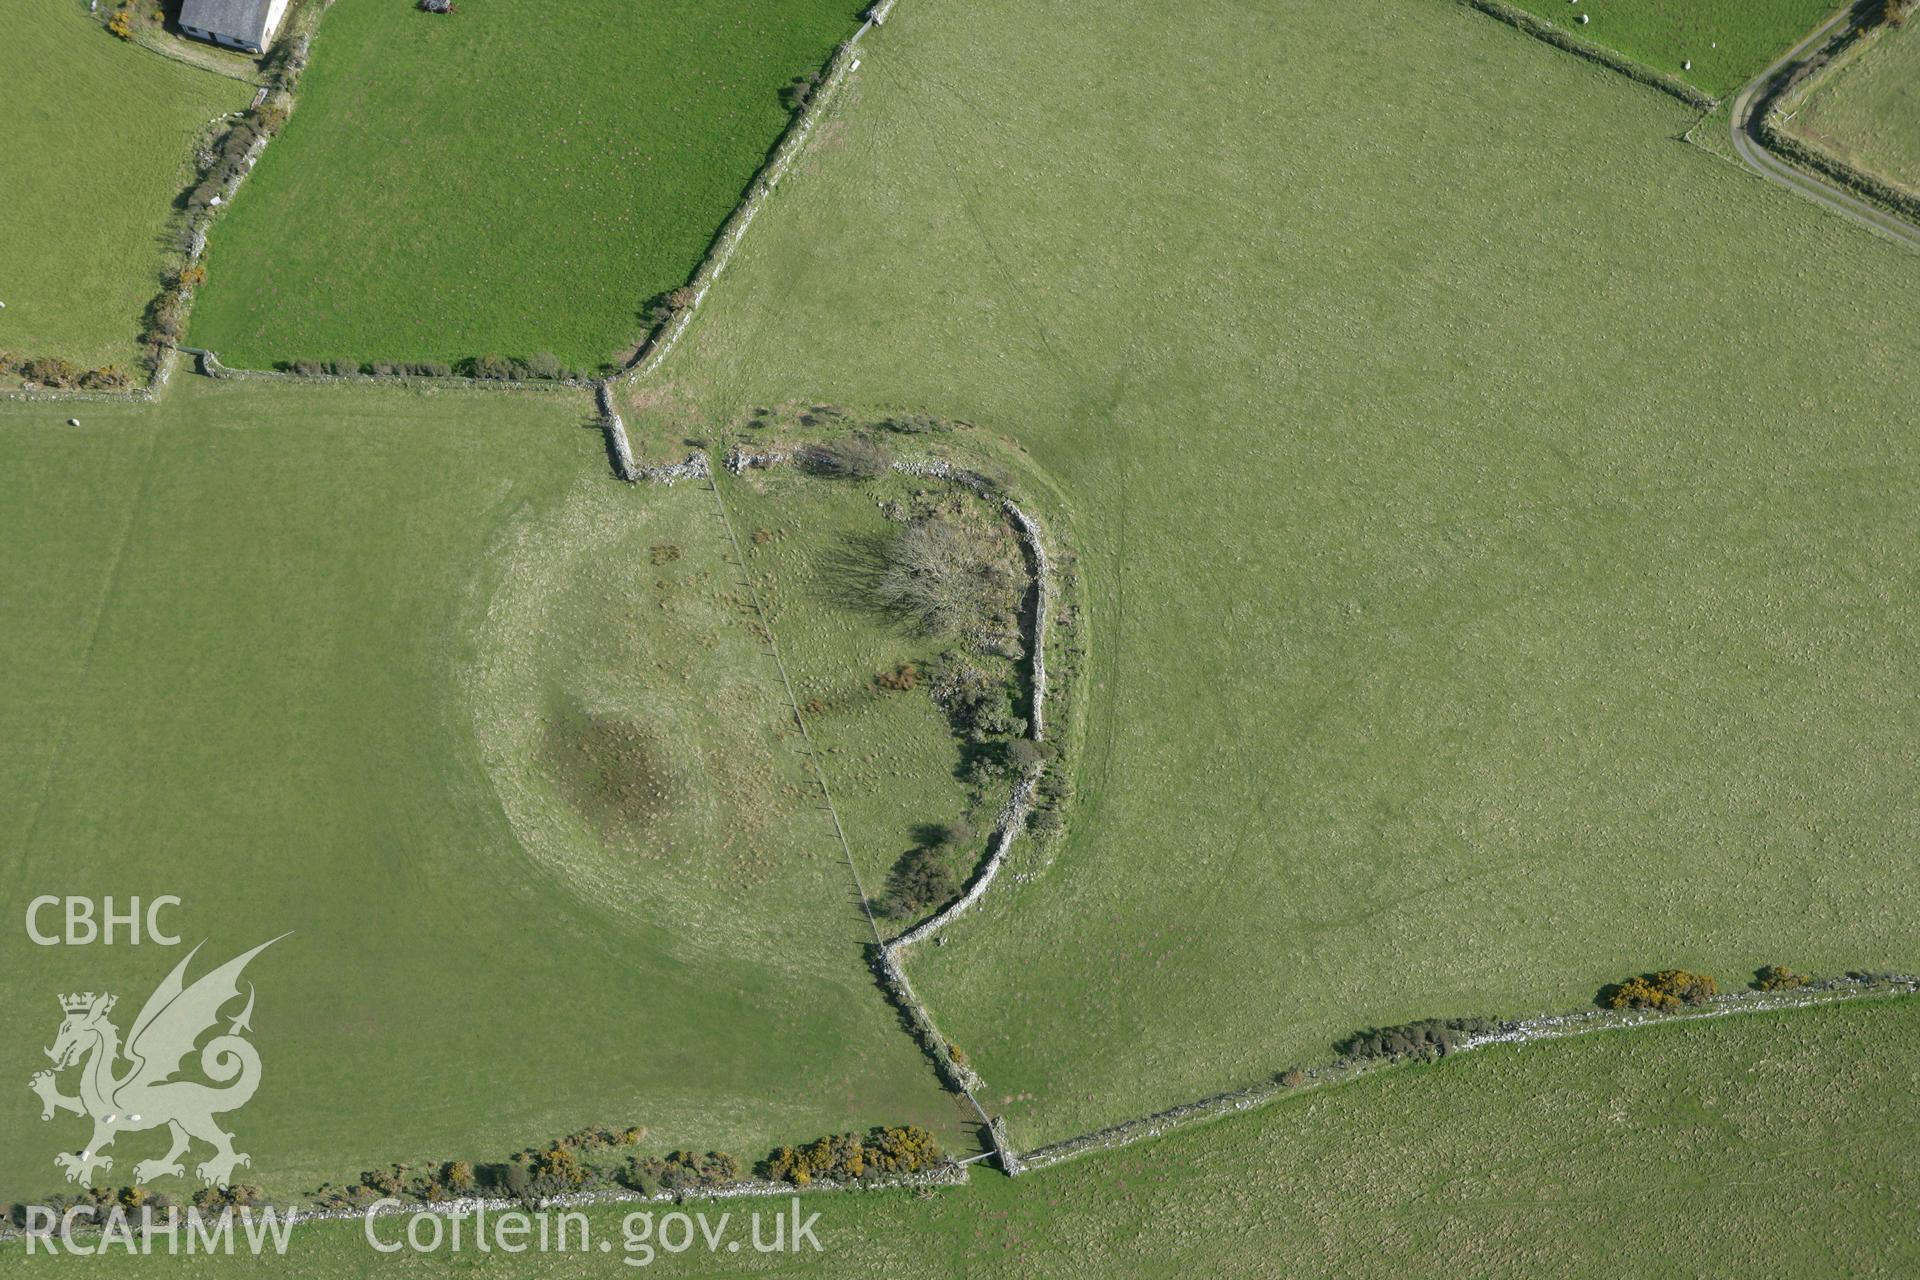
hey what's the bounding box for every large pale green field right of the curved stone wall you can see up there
[618,0,1920,1144]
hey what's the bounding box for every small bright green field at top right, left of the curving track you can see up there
[1511,0,1839,98]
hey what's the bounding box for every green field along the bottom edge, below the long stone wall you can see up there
[18,1000,1920,1278]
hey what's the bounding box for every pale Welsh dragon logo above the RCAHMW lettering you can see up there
[27,935,286,1186]
